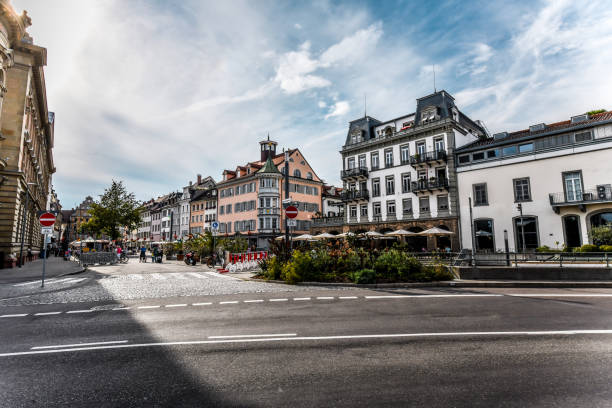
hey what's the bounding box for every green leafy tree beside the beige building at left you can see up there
[83,180,141,239]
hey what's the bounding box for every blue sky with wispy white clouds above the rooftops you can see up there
[12,0,612,208]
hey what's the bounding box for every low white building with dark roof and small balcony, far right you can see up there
[456,112,612,251]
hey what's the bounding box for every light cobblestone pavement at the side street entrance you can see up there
[0,259,334,306]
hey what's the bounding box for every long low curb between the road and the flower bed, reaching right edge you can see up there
[240,278,612,289]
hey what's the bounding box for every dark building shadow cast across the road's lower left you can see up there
[0,270,255,407]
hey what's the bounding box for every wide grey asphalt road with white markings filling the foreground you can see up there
[0,266,612,407]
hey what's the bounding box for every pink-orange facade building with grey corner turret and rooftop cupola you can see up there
[217,137,323,248]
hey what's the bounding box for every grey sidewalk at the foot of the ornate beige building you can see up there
[0,256,83,285]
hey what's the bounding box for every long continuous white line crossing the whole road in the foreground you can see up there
[0,330,612,357]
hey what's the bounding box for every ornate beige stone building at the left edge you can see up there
[0,0,55,267]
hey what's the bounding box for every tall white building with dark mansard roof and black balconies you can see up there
[326,91,486,250]
